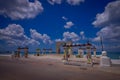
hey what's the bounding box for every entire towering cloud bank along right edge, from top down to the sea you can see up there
[92,0,120,51]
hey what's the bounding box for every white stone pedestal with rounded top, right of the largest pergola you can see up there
[100,51,111,67]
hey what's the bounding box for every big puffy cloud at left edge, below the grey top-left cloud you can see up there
[0,24,40,46]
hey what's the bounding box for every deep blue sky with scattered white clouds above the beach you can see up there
[0,0,120,51]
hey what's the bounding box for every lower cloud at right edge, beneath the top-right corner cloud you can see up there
[94,26,120,42]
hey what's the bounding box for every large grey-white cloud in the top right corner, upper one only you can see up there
[92,0,120,27]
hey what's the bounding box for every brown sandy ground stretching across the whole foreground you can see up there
[0,54,120,80]
